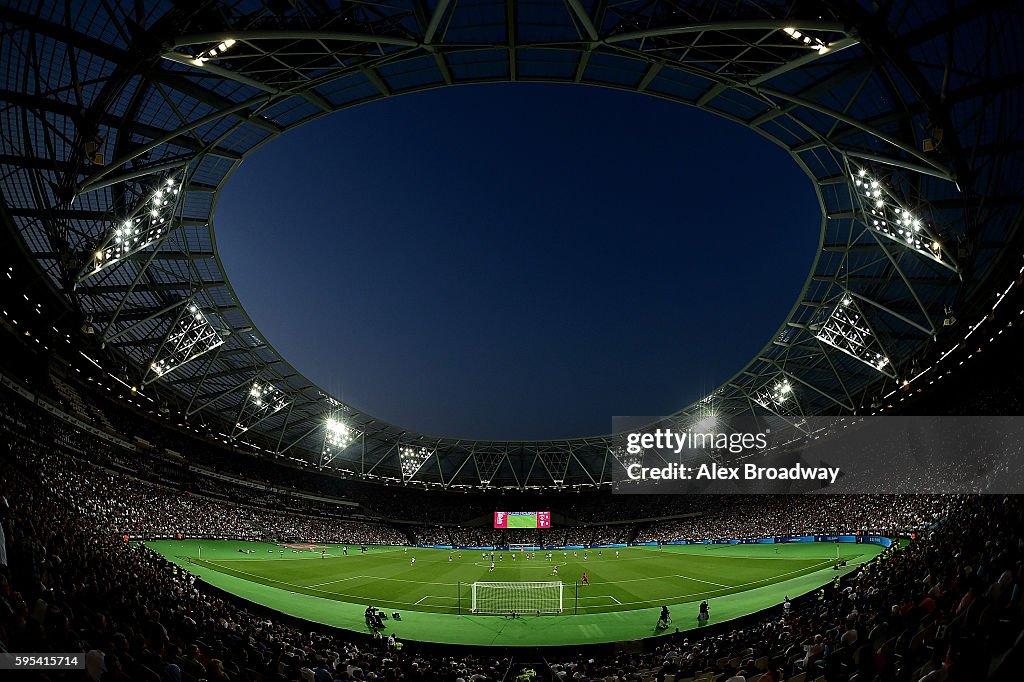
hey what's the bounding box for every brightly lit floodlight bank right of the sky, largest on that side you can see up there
[850,166,956,270]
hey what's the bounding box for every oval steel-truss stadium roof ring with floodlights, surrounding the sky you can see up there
[0,0,1024,486]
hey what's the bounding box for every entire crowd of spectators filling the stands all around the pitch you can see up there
[0,378,1024,682]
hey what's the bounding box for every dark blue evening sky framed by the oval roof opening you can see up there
[216,84,820,438]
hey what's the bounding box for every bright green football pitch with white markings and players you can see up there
[146,541,883,646]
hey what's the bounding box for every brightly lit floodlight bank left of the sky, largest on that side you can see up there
[78,172,184,282]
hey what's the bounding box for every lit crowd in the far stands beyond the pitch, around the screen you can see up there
[0,387,950,547]
